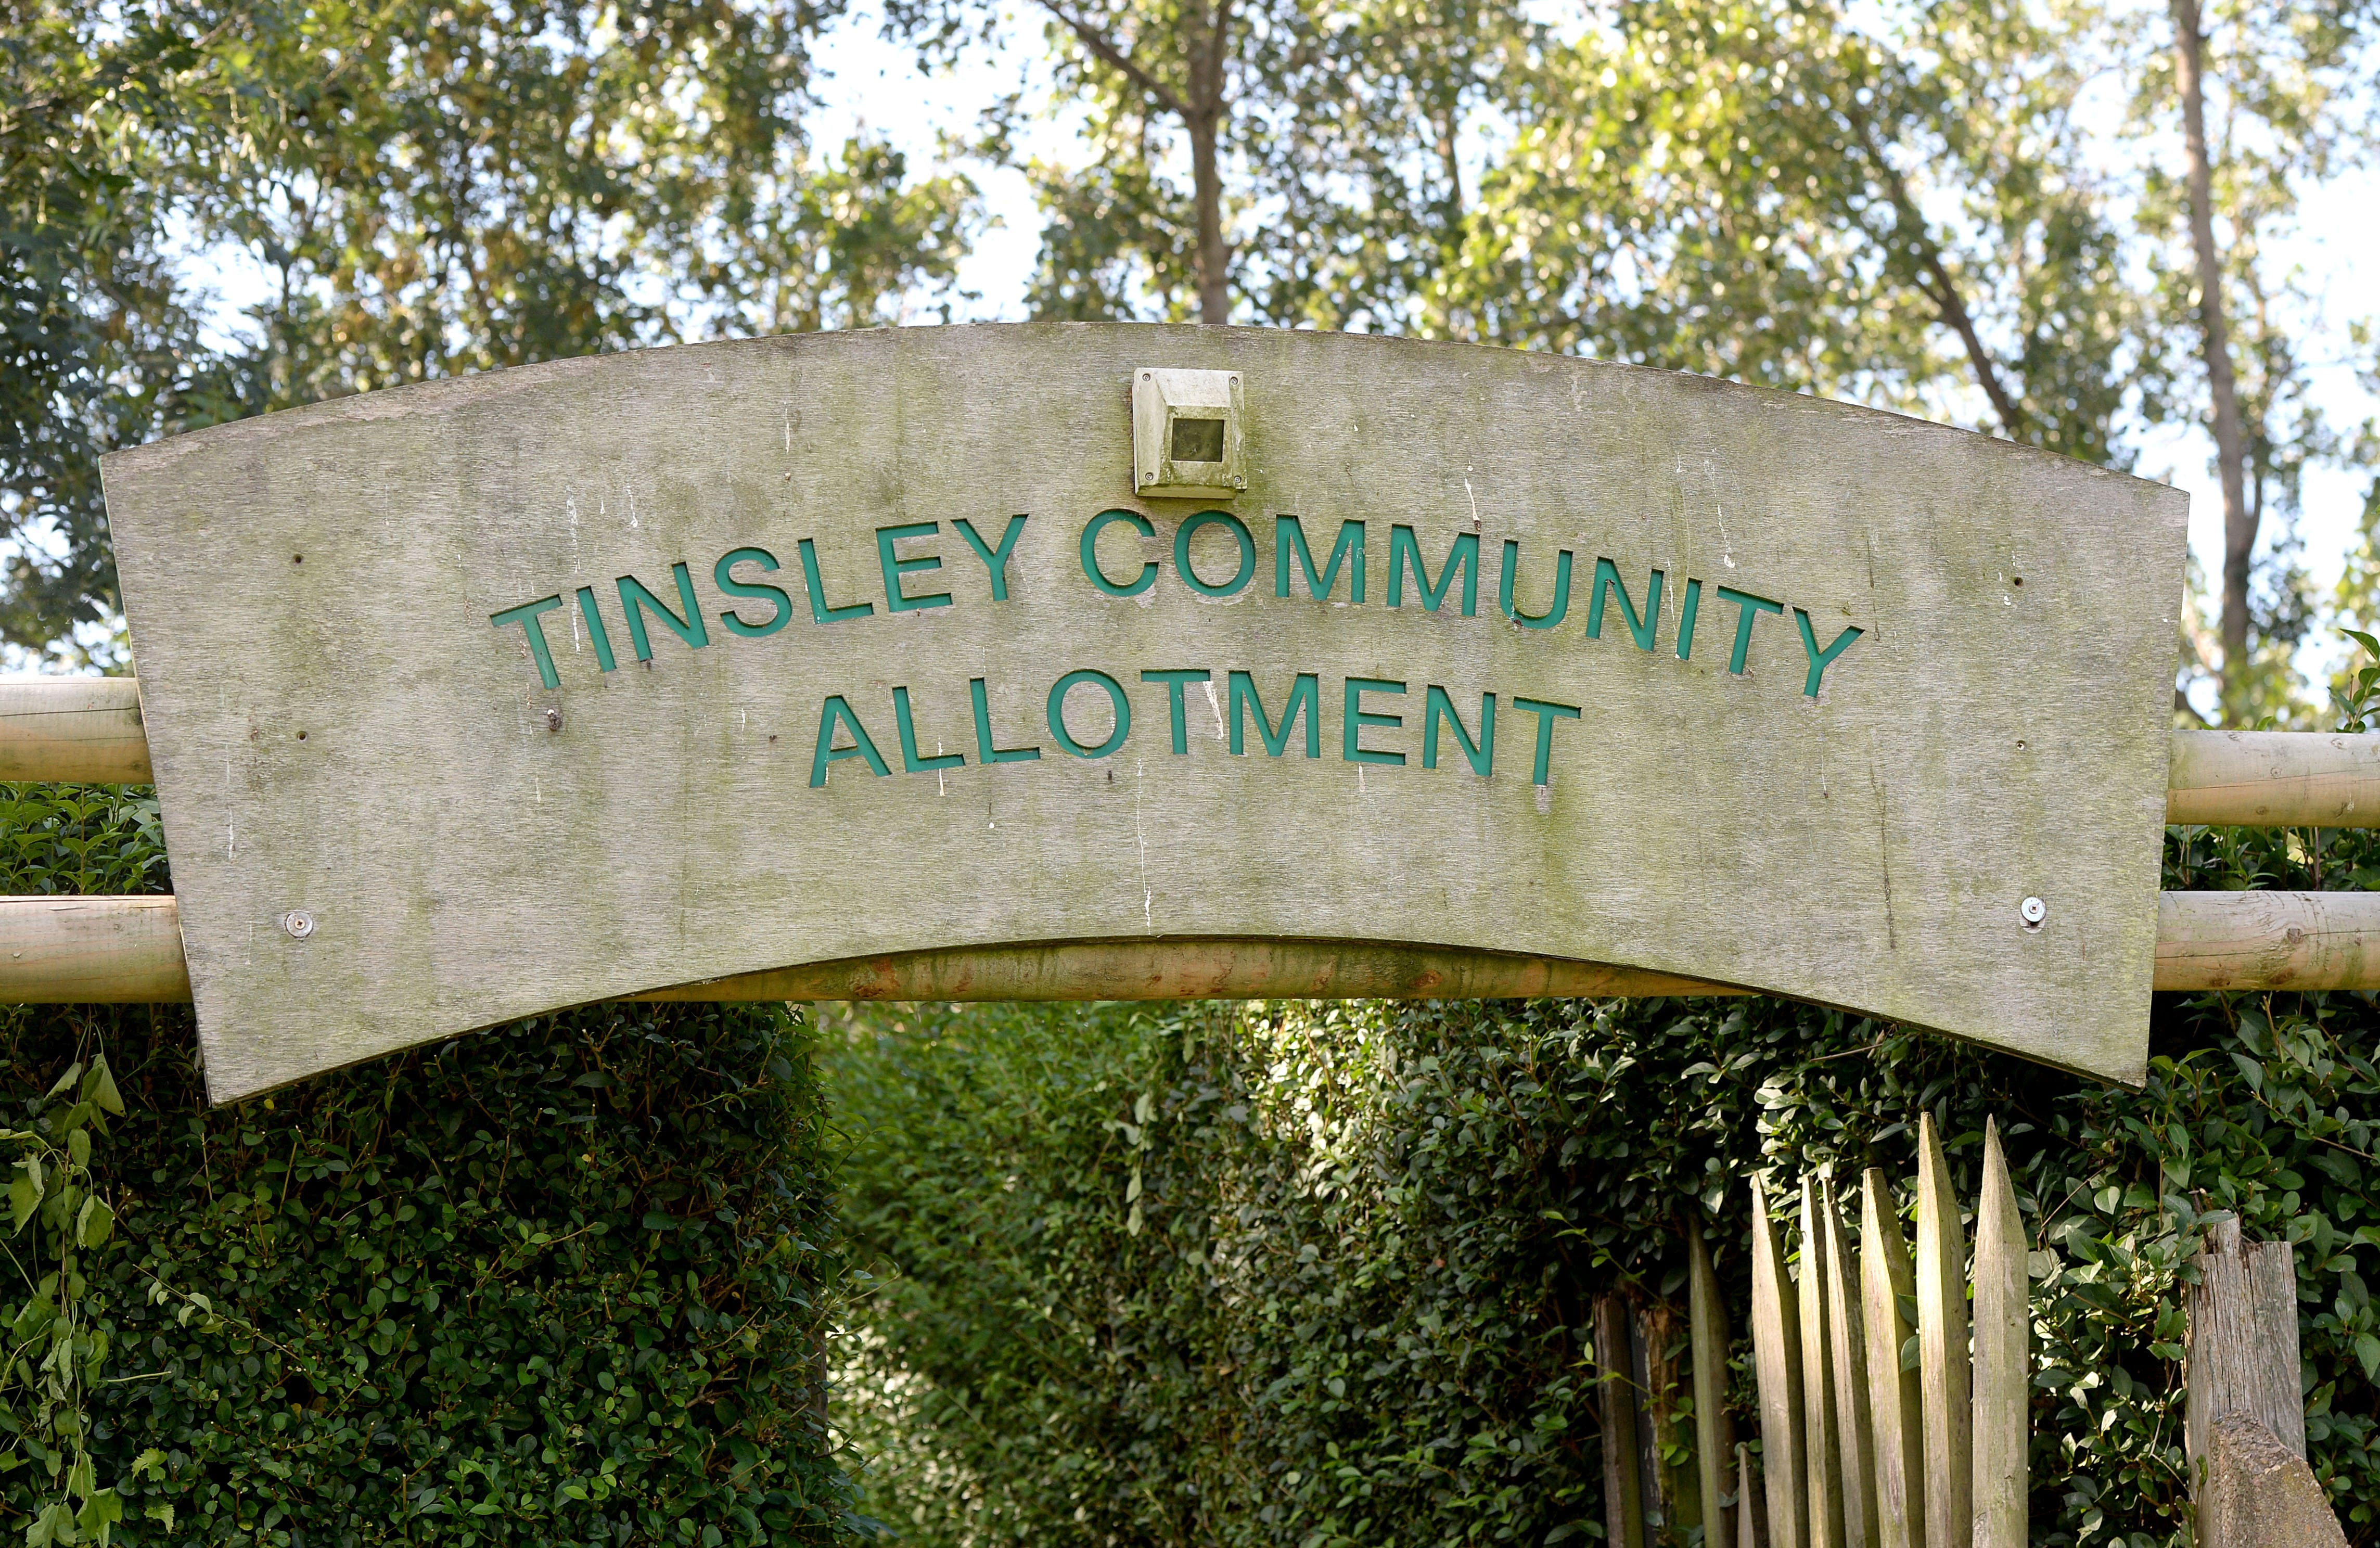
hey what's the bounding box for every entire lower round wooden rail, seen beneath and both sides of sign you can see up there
[0,893,2380,1005]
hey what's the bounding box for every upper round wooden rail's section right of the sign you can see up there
[2166,731,2380,829]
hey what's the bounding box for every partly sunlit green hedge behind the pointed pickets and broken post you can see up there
[826,829,2380,1548]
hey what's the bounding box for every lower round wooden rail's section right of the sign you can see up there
[2156,893,2380,988]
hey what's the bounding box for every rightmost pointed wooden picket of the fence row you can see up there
[1973,1119,2032,1548]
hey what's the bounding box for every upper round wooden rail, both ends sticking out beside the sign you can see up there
[0,676,2380,829]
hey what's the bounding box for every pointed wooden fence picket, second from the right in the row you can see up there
[1916,1112,1975,1548]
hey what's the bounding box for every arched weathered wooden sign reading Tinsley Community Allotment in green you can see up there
[105,324,2185,1101]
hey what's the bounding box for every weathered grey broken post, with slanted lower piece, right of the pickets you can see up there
[2182,1217,2347,1548]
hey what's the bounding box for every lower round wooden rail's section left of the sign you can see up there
[0,898,190,1005]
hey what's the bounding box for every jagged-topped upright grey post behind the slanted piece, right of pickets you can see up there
[2182,1217,2306,1477]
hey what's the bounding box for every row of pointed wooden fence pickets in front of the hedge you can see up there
[1597,1117,2030,1548]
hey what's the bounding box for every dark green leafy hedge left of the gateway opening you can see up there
[0,786,859,1548]
